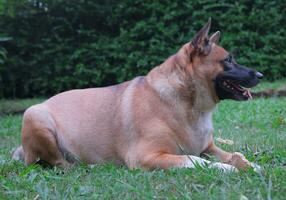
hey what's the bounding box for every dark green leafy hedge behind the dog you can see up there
[0,0,286,97]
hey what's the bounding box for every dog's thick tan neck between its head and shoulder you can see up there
[146,55,217,114]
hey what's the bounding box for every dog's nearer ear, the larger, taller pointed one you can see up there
[191,18,211,55]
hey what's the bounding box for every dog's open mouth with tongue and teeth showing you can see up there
[222,79,252,99]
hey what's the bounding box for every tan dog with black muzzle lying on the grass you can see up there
[12,19,263,171]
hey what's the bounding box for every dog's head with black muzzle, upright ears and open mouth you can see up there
[181,20,263,101]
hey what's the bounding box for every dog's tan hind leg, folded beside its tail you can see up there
[22,105,70,168]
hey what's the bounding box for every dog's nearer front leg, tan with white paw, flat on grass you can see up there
[140,154,236,172]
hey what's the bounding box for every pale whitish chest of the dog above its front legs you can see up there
[186,111,213,155]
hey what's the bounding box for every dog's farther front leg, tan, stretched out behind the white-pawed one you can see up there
[203,143,251,169]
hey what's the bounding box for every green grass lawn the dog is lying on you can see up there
[0,80,286,200]
